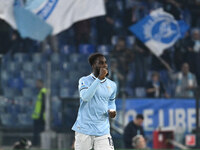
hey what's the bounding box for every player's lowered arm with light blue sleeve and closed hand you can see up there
[108,84,117,118]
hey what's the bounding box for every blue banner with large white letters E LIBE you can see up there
[116,98,196,145]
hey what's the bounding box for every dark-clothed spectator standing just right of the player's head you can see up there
[110,38,134,92]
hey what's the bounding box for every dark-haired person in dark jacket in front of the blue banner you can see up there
[123,114,144,148]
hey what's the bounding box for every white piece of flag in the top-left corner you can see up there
[0,0,17,29]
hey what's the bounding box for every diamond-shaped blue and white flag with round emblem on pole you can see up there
[130,9,189,56]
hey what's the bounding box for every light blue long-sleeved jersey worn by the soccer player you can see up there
[72,74,117,136]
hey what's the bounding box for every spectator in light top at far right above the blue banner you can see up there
[170,63,197,98]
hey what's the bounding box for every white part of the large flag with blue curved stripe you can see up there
[25,0,105,34]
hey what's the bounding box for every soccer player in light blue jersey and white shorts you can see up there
[72,53,117,150]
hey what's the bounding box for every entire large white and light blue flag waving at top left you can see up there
[0,0,105,41]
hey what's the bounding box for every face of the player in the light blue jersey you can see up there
[94,57,108,75]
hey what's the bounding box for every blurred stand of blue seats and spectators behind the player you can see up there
[0,0,200,144]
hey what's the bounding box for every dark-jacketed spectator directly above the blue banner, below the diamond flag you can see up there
[146,72,169,98]
